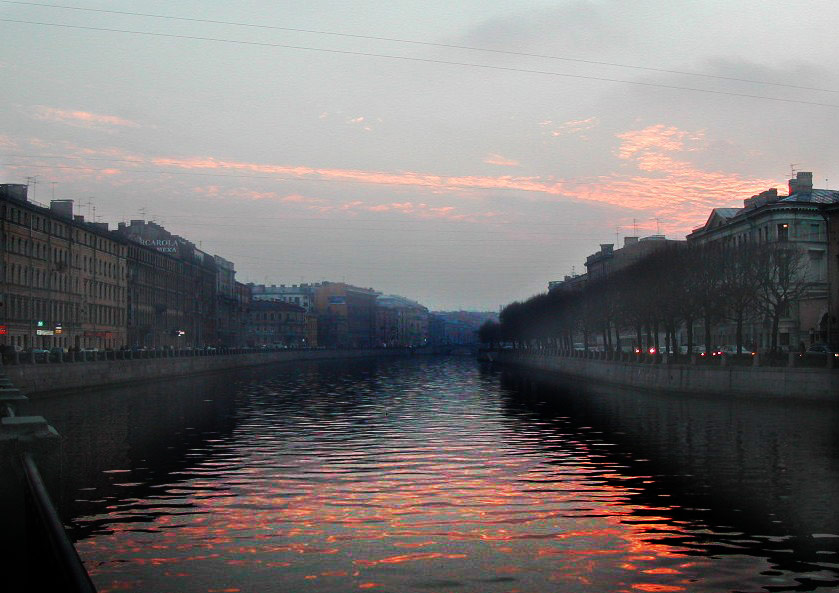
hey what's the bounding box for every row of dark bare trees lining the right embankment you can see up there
[480,243,811,353]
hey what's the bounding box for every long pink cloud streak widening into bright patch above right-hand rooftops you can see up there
[146,147,776,233]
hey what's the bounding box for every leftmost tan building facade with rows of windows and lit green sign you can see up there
[0,184,127,349]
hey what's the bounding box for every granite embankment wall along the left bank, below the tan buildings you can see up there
[3,349,408,395]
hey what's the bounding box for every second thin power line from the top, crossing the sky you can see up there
[0,18,839,108]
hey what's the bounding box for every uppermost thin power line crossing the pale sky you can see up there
[0,0,839,93]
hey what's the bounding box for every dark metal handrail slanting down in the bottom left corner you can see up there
[21,452,96,593]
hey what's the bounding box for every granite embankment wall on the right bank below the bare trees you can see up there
[494,351,839,401]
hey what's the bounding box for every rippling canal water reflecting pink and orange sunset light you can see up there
[31,357,839,593]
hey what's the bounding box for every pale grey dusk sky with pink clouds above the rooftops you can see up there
[0,0,839,310]
